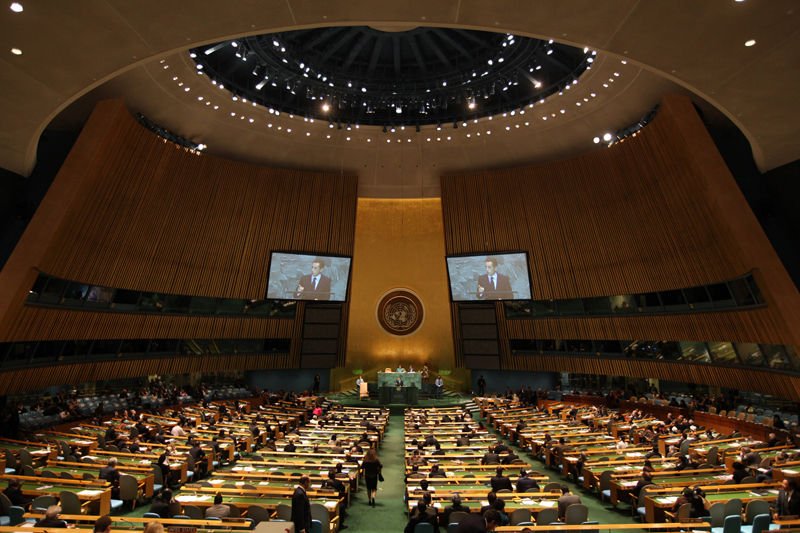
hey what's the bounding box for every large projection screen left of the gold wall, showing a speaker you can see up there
[265,252,351,302]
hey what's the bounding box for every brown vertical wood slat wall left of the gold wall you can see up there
[0,101,358,378]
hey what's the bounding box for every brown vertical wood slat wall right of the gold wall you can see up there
[441,94,794,391]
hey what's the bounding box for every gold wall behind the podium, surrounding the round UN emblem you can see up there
[332,198,467,388]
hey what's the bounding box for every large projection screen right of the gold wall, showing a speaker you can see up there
[447,252,531,302]
